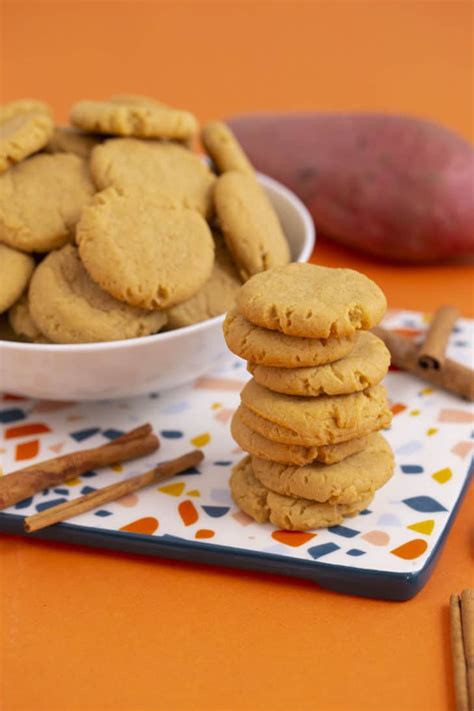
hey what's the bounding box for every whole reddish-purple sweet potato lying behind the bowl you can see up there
[227,113,474,262]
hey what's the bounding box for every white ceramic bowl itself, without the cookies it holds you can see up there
[0,175,315,400]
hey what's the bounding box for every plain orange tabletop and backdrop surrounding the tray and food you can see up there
[0,0,474,711]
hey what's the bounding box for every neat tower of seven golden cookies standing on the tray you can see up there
[224,264,393,530]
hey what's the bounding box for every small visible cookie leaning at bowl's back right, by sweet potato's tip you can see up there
[202,121,255,175]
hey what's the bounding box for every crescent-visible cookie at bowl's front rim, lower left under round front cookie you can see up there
[29,245,166,343]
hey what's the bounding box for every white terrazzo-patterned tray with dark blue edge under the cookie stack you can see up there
[0,312,474,600]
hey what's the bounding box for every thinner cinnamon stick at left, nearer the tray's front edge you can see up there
[24,449,204,533]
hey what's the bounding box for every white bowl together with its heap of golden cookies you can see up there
[0,95,315,400]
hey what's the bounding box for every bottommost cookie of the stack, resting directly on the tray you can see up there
[230,457,373,531]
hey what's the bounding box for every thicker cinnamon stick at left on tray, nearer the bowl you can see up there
[0,424,160,510]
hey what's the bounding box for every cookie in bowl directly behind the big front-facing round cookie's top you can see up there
[91,138,216,216]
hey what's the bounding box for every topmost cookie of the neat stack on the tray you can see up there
[235,262,387,338]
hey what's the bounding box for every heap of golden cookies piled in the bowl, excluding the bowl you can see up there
[0,95,290,343]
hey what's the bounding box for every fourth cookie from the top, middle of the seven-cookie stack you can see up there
[240,379,391,447]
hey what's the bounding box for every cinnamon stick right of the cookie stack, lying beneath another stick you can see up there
[373,326,474,402]
